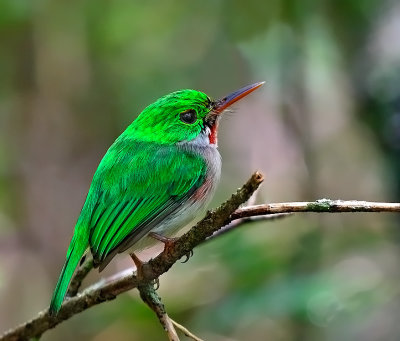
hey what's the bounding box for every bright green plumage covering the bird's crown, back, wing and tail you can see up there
[50,90,211,314]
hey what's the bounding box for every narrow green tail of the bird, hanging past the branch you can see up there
[49,232,87,316]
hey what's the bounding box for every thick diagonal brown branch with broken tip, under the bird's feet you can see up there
[0,172,263,341]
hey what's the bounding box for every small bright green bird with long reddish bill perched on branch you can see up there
[49,82,264,315]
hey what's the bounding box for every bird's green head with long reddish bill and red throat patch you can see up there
[125,82,264,145]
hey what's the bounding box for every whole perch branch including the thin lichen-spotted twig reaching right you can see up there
[0,177,400,341]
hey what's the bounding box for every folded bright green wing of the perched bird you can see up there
[82,140,206,270]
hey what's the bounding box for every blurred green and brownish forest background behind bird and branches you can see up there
[0,0,400,341]
